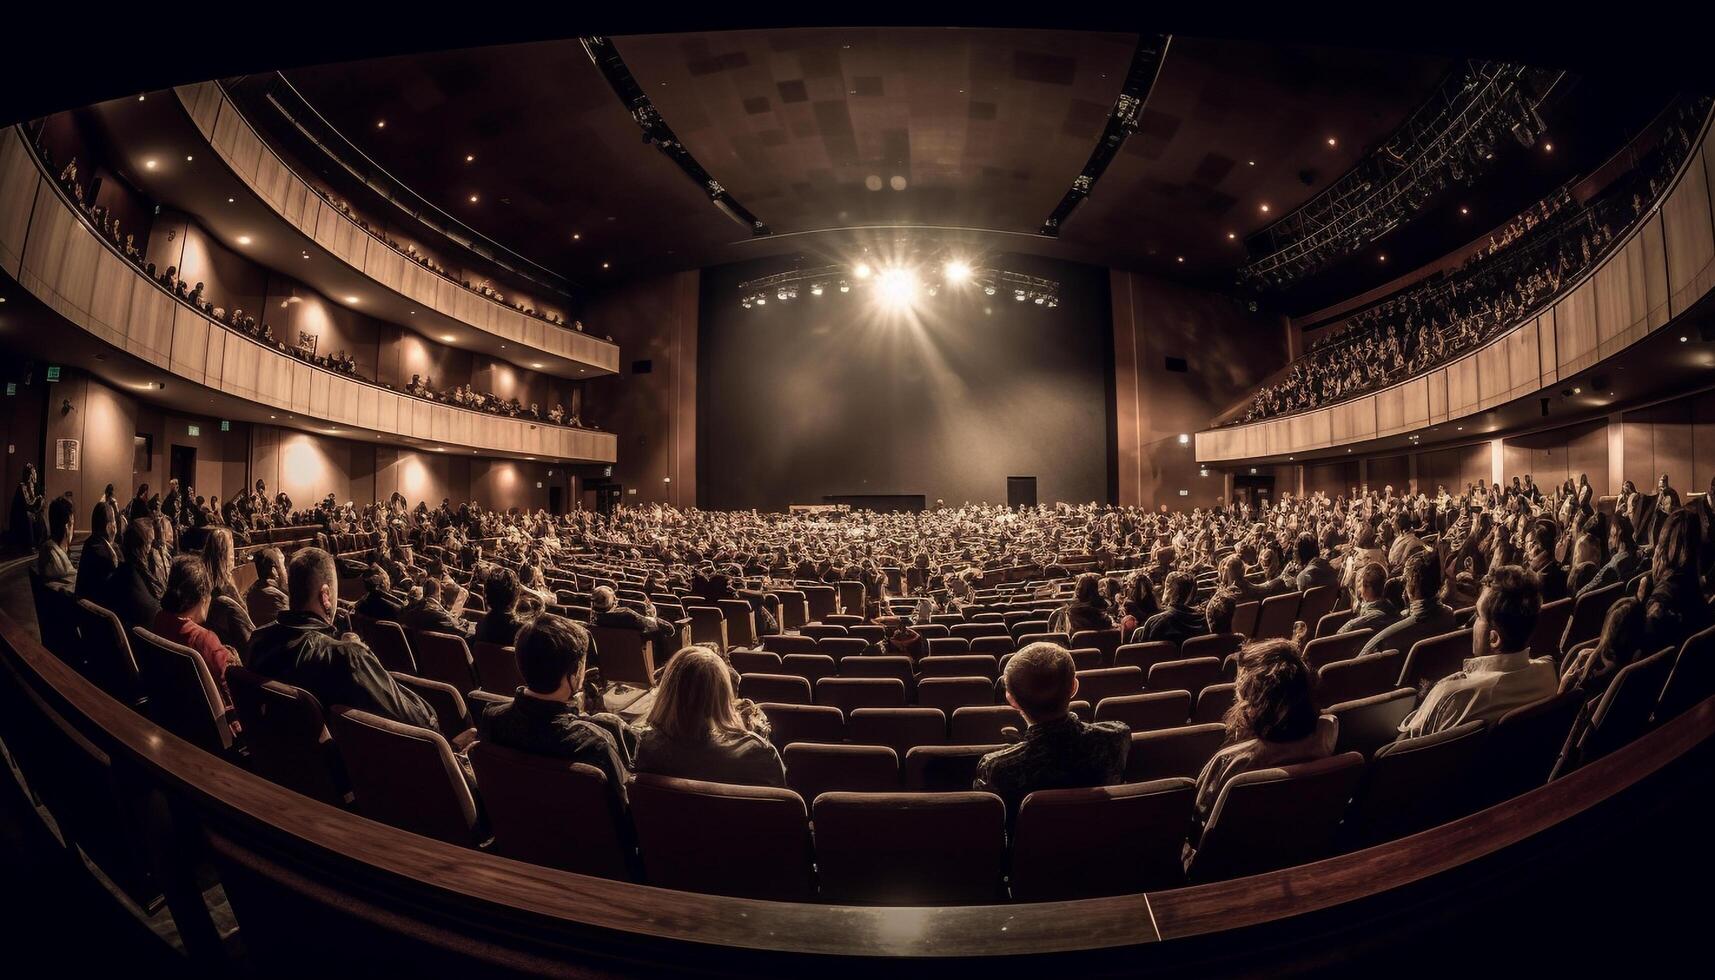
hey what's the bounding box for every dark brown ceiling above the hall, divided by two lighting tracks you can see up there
[277,27,1451,285]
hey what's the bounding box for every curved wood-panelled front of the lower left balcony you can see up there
[0,127,617,462]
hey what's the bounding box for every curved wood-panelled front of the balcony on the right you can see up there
[1197,108,1715,463]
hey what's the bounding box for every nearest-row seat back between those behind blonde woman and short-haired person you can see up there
[811,793,1007,904]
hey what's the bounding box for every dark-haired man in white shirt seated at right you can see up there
[1399,565,1559,736]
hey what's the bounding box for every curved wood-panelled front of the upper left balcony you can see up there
[173,82,619,378]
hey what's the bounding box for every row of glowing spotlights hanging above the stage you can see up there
[739,249,1060,309]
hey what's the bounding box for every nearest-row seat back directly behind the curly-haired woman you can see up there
[1185,752,1363,884]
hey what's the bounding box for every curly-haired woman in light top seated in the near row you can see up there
[1197,640,1339,824]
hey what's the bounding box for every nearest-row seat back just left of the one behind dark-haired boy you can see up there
[331,705,482,848]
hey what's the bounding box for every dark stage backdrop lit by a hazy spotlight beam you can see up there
[696,256,1115,510]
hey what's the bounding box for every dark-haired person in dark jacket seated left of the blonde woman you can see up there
[477,614,636,800]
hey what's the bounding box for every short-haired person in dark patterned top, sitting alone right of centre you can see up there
[971,644,1132,820]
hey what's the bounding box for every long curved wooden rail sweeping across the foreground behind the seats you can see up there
[0,590,1715,963]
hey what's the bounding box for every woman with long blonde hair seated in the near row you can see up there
[636,647,785,786]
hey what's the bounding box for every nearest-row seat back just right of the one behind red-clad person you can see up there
[226,664,350,807]
